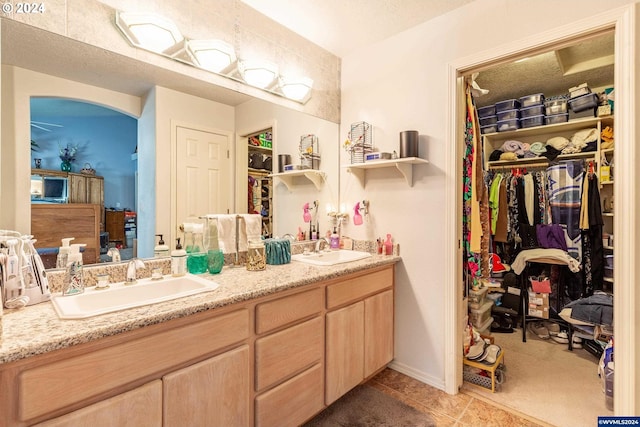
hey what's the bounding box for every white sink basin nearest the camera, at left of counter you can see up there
[51,274,220,319]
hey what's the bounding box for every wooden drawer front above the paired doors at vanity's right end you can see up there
[327,267,393,309]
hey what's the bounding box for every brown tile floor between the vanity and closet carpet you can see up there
[368,368,548,427]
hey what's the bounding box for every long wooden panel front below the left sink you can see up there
[17,309,250,421]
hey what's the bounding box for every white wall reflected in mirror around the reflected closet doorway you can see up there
[236,99,339,236]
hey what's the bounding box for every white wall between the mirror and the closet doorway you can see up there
[340,0,633,388]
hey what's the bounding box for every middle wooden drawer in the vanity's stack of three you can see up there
[255,317,324,391]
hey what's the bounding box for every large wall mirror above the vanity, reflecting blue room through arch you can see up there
[0,18,339,268]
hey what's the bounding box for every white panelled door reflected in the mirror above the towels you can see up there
[175,126,231,225]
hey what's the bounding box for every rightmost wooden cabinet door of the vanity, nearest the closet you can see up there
[364,291,393,378]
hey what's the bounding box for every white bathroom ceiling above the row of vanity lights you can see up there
[241,0,473,57]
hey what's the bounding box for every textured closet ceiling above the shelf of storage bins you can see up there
[476,32,614,107]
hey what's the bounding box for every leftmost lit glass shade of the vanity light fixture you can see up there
[116,12,184,53]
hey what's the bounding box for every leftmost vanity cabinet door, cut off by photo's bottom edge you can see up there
[35,380,162,427]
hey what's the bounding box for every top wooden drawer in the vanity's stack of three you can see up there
[256,288,323,334]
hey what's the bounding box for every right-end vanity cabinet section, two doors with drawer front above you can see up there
[325,269,393,405]
